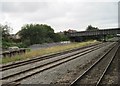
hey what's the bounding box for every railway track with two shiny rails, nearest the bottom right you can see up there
[69,43,120,86]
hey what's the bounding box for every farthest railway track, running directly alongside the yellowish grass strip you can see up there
[0,43,102,71]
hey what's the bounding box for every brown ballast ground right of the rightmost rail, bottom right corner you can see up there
[100,47,120,86]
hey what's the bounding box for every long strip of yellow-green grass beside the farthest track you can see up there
[0,40,98,64]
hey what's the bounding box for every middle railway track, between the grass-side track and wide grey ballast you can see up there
[1,44,114,82]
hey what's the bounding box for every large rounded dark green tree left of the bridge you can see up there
[19,24,54,45]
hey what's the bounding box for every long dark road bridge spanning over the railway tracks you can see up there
[66,28,120,41]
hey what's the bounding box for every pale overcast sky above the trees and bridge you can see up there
[0,0,119,33]
